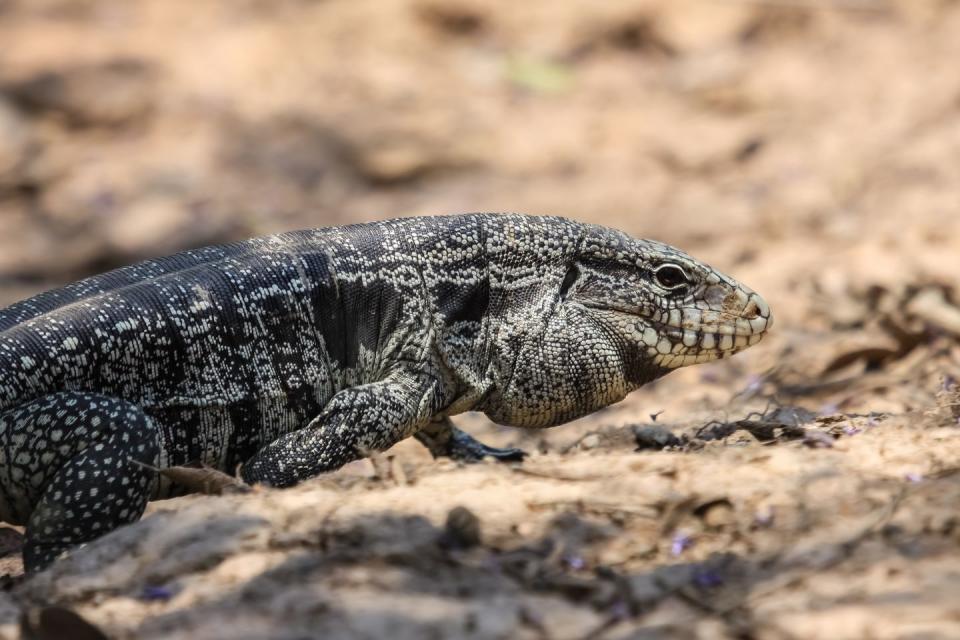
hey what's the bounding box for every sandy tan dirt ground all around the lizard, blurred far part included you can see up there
[0,0,960,640]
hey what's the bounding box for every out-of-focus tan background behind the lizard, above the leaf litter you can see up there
[0,0,960,308]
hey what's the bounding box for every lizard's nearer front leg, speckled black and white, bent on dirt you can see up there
[240,371,441,487]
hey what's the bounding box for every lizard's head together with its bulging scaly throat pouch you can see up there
[487,218,773,426]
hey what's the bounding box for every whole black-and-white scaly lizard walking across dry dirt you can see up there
[0,214,771,570]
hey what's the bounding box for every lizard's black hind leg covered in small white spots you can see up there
[0,392,160,572]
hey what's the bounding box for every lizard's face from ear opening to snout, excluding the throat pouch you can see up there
[558,232,773,370]
